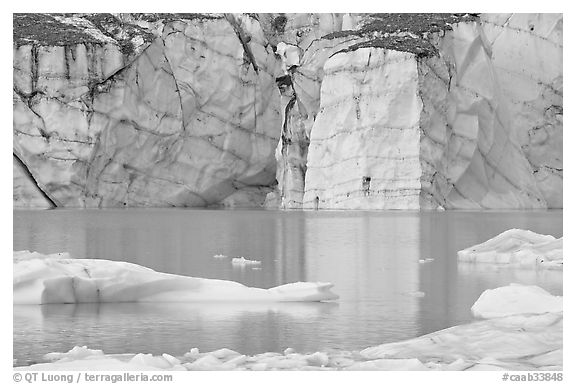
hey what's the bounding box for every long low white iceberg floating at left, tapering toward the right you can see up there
[14,251,338,304]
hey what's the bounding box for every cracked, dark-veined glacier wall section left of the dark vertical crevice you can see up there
[14,15,280,207]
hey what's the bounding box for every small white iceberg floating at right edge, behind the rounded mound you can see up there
[458,229,563,268]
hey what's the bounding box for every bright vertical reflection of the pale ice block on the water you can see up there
[306,212,420,348]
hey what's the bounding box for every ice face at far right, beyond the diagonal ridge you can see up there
[482,13,563,208]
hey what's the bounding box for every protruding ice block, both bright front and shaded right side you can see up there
[304,16,558,209]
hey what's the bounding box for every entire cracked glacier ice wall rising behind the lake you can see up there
[14,14,563,209]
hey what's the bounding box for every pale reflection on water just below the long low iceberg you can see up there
[14,303,338,363]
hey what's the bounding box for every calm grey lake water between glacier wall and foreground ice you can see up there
[13,209,563,365]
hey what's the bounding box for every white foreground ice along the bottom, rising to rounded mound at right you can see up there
[16,285,563,371]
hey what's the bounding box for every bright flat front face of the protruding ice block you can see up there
[304,48,421,209]
